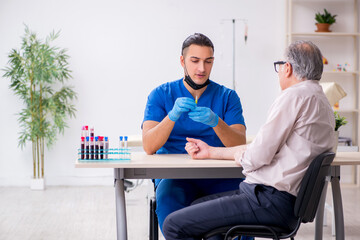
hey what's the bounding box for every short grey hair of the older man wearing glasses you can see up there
[285,41,324,80]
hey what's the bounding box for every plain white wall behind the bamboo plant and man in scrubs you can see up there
[0,0,285,186]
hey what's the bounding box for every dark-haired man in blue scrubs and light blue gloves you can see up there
[142,33,246,235]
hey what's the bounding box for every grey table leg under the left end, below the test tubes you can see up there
[114,168,127,240]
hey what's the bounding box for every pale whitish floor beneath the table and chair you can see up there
[0,184,360,240]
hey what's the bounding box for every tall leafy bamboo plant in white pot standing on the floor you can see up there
[4,26,76,189]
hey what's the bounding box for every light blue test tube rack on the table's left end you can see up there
[78,148,131,161]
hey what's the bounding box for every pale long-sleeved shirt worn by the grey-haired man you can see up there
[238,80,335,196]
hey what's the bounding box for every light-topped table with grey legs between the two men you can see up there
[75,152,360,240]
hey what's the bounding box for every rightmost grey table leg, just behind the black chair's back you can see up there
[331,166,345,240]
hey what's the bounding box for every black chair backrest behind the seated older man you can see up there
[294,152,335,223]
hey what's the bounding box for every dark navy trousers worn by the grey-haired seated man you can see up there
[163,182,297,240]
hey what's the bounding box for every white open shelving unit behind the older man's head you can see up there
[286,0,360,145]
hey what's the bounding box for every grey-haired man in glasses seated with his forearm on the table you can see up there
[163,41,335,240]
